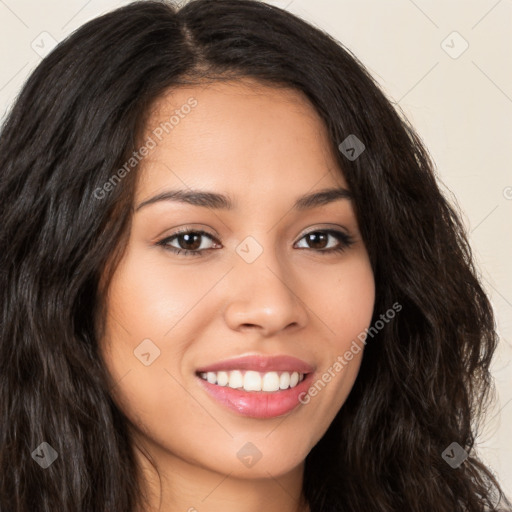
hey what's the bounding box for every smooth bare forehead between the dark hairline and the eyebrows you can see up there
[138,80,346,197]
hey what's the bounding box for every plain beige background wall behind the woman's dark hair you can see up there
[0,0,512,497]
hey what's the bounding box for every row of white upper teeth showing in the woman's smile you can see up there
[199,370,304,392]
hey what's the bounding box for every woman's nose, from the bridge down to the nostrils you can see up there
[224,244,308,337]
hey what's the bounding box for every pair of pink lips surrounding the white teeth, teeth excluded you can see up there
[196,356,314,418]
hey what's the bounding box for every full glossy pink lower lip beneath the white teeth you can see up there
[197,373,313,418]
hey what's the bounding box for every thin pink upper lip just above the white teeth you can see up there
[196,355,314,373]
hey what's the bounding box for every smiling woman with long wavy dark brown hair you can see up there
[0,0,510,512]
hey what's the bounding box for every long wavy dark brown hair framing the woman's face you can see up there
[0,0,510,512]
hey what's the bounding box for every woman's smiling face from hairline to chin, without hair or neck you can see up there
[101,81,375,478]
